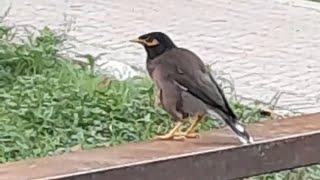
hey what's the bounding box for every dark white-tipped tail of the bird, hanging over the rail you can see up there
[207,110,253,144]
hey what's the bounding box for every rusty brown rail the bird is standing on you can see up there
[0,113,320,180]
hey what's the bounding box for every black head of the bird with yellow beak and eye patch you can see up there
[130,32,176,60]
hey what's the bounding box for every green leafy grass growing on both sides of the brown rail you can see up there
[0,26,320,179]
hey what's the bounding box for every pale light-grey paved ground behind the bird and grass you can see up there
[0,0,320,113]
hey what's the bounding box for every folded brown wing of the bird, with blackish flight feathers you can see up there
[161,49,235,117]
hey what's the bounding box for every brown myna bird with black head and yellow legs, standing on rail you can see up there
[131,32,253,144]
